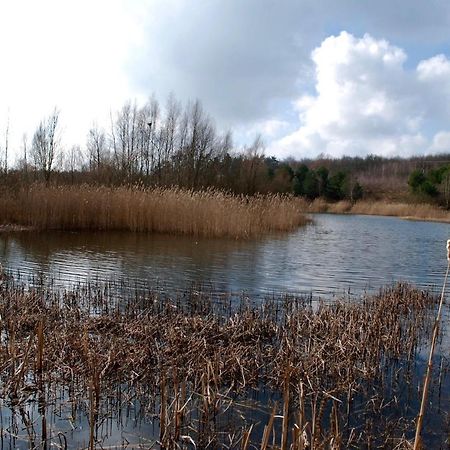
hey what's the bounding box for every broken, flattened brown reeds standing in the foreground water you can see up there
[0,278,444,449]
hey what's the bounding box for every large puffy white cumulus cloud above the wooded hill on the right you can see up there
[269,32,450,157]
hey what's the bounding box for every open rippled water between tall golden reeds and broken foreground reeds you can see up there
[0,215,449,296]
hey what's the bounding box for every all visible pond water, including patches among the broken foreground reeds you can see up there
[0,214,450,449]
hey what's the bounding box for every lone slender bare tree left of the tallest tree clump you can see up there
[31,109,60,183]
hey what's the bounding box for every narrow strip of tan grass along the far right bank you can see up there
[304,199,450,222]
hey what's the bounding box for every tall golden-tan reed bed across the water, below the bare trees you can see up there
[0,185,306,239]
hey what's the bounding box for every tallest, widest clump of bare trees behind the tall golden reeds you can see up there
[107,95,231,189]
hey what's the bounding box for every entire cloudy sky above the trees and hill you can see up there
[0,0,450,162]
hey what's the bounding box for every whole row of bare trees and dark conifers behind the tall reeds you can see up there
[0,95,370,200]
